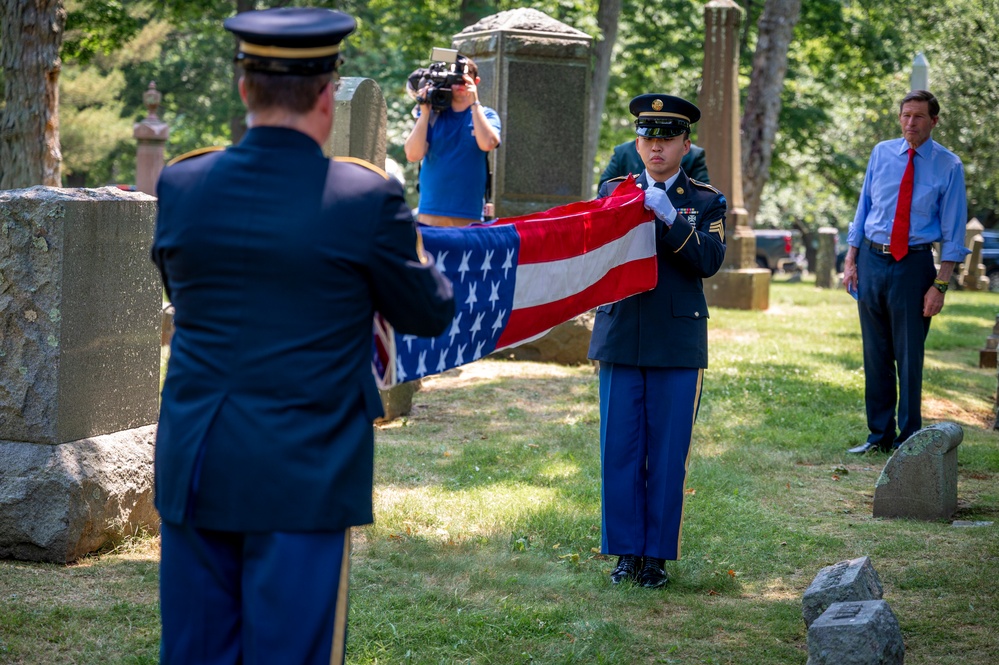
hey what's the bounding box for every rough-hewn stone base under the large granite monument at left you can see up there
[0,425,160,563]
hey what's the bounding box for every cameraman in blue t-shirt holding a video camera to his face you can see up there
[405,56,500,226]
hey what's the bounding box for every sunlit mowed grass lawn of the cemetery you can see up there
[0,281,999,665]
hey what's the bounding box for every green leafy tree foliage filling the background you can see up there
[52,0,999,232]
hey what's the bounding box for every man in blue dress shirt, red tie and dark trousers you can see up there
[843,90,969,453]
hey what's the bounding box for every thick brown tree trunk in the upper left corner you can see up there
[0,0,66,189]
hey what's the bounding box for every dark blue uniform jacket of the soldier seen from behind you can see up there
[152,127,454,531]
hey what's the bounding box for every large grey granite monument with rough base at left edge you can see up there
[0,187,162,562]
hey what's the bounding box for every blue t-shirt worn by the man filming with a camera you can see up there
[420,106,500,220]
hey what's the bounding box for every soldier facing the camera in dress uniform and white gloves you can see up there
[589,94,727,588]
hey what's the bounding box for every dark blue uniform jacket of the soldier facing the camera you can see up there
[589,169,727,368]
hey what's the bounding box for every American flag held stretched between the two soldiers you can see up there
[372,178,657,390]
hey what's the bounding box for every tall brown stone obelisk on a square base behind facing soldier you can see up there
[697,0,770,310]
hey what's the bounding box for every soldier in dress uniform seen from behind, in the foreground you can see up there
[152,8,454,665]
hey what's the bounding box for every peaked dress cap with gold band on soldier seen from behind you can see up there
[222,7,357,76]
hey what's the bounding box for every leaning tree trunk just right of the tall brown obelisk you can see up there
[742,0,801,226]
